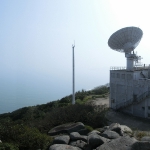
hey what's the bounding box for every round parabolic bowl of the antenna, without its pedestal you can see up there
[108,27,143,53]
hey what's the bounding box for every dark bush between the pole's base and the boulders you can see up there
[38,104,107,132]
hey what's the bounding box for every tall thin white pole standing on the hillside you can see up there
[72,45,75,104]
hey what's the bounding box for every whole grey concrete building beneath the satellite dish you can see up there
[109,65,150,118]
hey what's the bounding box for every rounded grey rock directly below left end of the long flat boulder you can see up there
[53,135,70,144]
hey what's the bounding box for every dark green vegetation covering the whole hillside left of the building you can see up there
[0,86,109,150]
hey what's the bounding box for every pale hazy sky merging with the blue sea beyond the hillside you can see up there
[0,0,150,113]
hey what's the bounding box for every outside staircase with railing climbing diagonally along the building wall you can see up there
[116,91,150,110]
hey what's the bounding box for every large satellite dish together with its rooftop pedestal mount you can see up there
[108,27,143,71]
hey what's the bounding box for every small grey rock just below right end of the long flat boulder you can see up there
[70,132,87,142]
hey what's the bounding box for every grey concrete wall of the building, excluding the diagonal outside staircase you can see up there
[110,69,150,118]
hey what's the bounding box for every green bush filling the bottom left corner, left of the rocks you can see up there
[0,122,53,150]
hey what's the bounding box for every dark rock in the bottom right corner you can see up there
[131,141,150,150]
